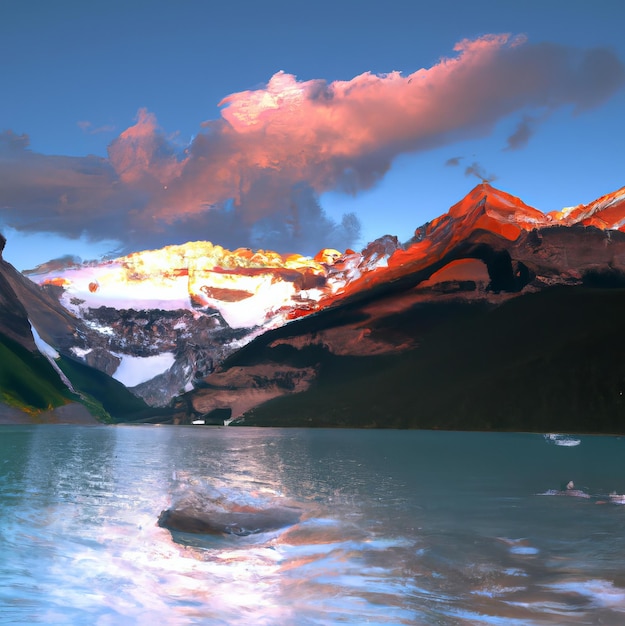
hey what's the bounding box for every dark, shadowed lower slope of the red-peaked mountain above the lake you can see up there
[244,287,625,433]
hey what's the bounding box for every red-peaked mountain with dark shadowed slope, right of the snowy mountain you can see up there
[172,180,625,432]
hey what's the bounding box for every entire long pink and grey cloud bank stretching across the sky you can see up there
[0,35,625,253]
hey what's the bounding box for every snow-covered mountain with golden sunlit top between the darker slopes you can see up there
[29,237,399,405]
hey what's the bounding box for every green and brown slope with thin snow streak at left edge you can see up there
[0,235,166,423]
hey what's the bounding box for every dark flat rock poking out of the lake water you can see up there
[158,506,302,537]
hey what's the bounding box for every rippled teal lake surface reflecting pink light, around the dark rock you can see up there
[0,426,625,626]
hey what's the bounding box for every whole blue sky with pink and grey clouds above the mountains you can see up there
[0,0,625,270]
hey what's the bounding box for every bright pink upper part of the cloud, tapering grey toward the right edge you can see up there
[143,35,625,225]
